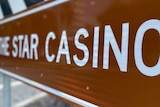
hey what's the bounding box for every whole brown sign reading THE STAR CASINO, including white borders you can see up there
[0,0,160,107]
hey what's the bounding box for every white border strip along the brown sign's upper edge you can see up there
[0,0,69,25]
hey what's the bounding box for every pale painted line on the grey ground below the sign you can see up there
[13,92,47,107]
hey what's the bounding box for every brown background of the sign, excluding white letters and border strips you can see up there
[0,0,160,107]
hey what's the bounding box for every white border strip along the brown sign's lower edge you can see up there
[0,68,99,107]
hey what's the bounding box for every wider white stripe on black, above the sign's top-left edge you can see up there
[8,0,27,14]
